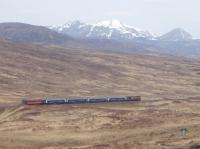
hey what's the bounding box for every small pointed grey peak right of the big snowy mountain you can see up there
[159,28,192,41]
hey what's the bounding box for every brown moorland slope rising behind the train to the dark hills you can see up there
[0,41,200,103]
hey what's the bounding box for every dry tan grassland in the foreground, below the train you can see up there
[0,100,200,149]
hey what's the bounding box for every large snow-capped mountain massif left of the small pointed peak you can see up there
[50,20,155,40]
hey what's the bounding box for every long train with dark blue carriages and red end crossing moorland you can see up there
[22,96,141,105]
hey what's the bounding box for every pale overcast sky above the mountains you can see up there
[0,0,200,38]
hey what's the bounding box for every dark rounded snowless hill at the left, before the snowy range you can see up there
[0,23,73,44]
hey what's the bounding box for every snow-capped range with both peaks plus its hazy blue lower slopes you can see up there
[50,20,200,57]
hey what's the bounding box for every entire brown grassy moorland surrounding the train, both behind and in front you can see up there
[0,41,200,149]
